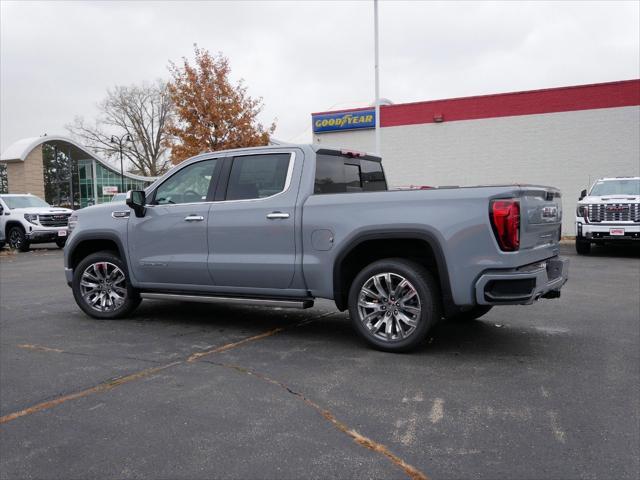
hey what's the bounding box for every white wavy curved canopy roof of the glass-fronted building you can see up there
[0,135,157,182]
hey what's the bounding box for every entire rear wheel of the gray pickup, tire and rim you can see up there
[349,258,440,352]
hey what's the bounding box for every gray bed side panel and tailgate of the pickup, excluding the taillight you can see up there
[303,185,562,305]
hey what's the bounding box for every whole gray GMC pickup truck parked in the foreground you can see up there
[65,145,568,351]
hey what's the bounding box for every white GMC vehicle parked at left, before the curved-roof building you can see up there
[0,194,73,252]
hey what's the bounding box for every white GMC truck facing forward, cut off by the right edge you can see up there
[576,177,640,251]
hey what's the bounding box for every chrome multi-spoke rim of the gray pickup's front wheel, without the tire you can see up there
[80,262,127,312]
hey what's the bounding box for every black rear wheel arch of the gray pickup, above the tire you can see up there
[333,229,453,310]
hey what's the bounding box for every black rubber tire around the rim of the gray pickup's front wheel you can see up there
[72,251,141,320]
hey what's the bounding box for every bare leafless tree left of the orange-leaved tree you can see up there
[66,80,173,176]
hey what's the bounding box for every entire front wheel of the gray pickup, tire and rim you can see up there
[72,251,140,319]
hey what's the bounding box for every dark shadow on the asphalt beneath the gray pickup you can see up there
[129,301,556,358]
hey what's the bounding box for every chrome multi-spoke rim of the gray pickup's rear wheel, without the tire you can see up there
[358,273,422,341]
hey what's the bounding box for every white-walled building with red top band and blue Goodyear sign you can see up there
[312,80,640,235]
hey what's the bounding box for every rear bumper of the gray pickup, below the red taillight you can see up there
[475,256,569,305]
